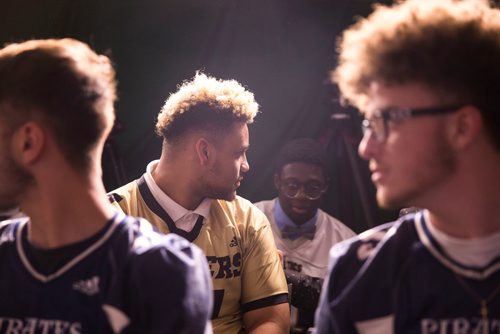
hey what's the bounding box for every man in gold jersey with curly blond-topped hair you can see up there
[110,73,289,333]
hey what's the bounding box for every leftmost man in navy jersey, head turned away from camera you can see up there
[0,39,212,334]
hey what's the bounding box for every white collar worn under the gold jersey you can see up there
[144,160,211,232]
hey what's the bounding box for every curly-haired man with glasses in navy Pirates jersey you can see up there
[316,0,500,334]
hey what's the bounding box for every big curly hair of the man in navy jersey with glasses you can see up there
[333,0,500,149]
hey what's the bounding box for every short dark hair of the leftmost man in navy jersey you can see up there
[0,39,116,168]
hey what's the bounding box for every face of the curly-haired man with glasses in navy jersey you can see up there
[359,83,456,208]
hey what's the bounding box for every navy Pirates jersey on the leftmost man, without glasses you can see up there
[0,214,212,334]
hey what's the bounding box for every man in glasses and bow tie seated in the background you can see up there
[255,138,355,333]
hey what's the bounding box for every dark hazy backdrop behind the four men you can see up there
[0,0,396,232]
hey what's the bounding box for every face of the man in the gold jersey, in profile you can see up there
[206,122,250,201]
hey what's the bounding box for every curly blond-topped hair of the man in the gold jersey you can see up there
[156,72,259,141]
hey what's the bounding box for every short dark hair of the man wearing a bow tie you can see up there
[274,138,329,179]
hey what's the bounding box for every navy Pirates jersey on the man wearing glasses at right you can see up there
[316,212,500,334]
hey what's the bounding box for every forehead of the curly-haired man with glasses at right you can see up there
[364,82,442,117]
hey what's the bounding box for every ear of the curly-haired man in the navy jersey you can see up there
[447,105,483,150]
